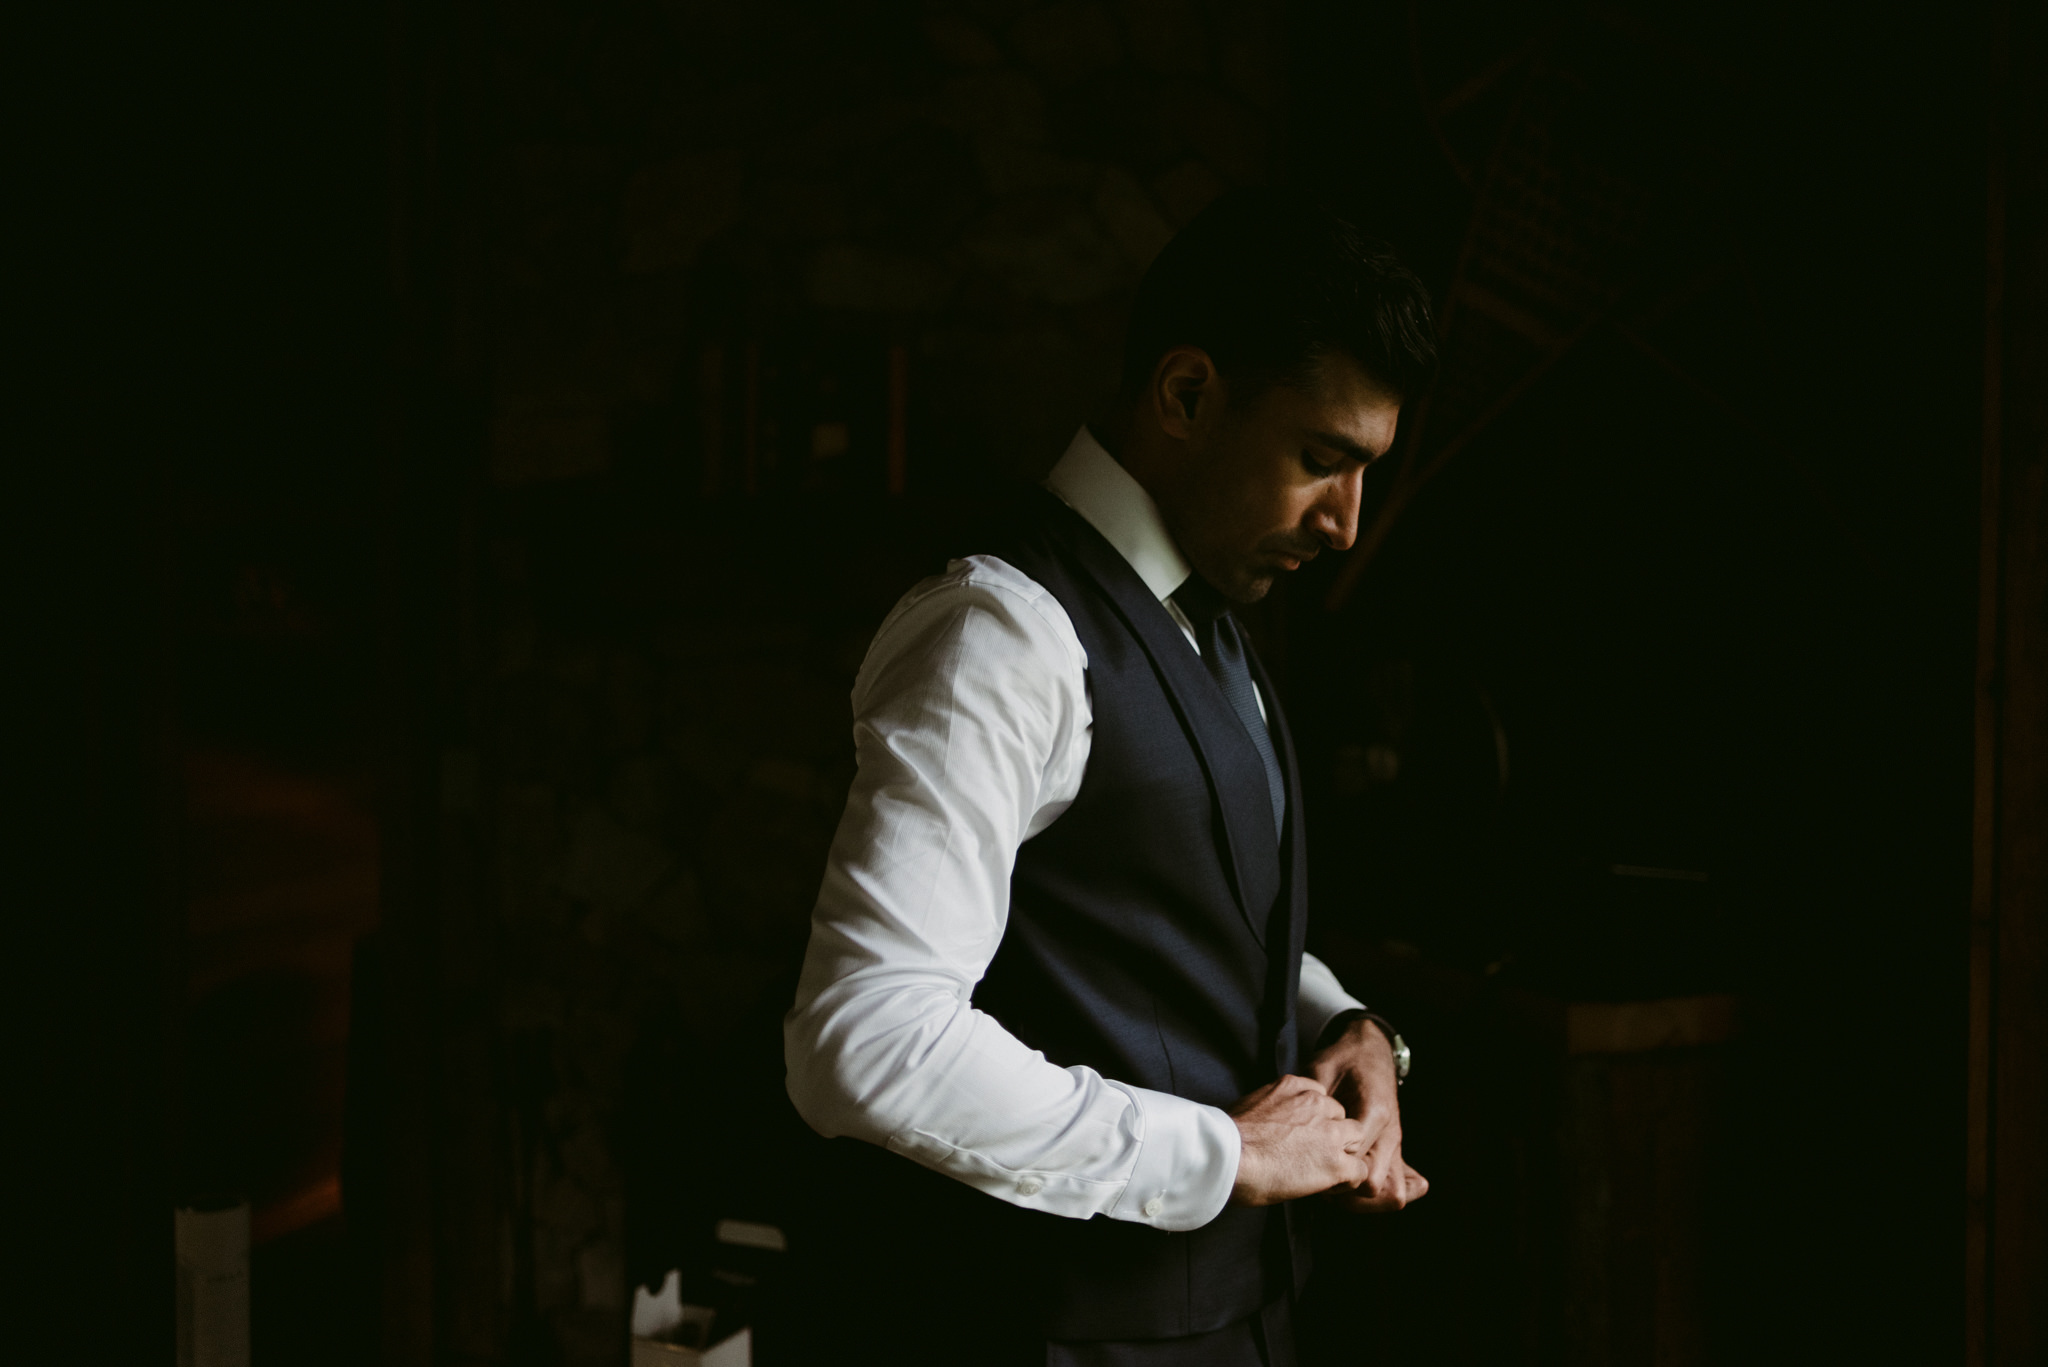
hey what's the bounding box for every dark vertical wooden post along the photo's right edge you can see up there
[1964,0,2048,1367]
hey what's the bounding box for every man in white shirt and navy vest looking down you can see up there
[784,193,1434,1367]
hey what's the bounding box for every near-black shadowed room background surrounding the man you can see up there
[16,0,2040,1363]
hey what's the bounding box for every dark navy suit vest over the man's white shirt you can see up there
[790,490,1309,1361]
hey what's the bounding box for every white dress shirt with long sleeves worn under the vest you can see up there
[782,428,1360,1230]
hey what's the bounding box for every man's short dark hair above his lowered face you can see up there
[1122,189,1436,400]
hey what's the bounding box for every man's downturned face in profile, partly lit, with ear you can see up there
[1155,357,1401,603]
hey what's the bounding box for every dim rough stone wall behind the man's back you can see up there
[471,0,1280,1363]
